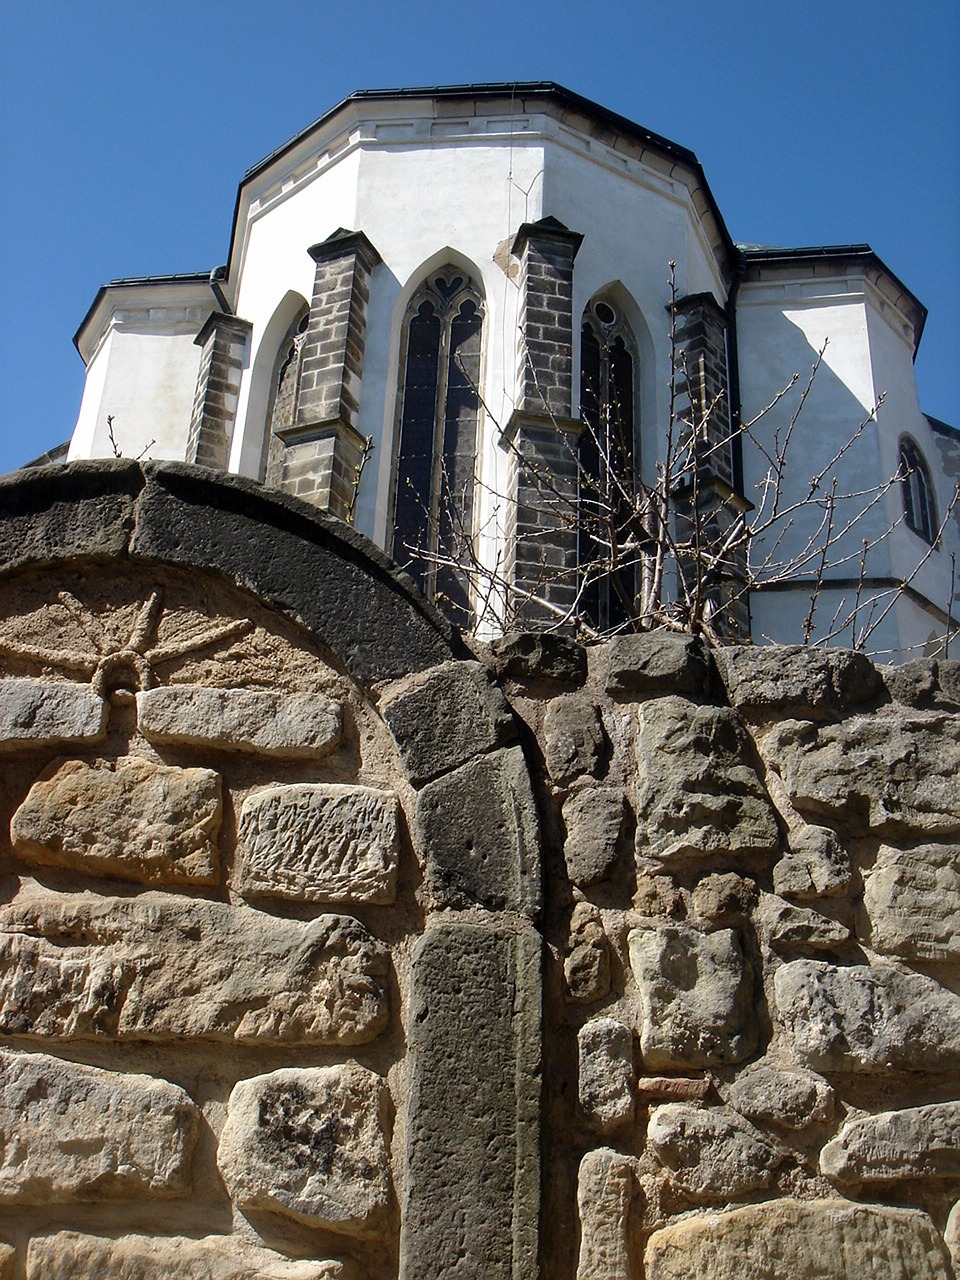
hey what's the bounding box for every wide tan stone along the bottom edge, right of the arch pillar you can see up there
[645,1199,948,1280]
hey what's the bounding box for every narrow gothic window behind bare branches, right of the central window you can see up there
[579,297,640,631]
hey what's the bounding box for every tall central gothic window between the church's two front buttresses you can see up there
[392,268,484,625]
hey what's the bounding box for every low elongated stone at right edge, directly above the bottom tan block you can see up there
[820,1102,960,1183]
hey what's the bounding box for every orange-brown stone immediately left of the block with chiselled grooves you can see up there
[10,756,221,884]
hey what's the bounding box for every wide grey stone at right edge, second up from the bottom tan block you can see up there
[774,960,960,1071]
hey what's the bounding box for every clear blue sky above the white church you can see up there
[0,0,960,471]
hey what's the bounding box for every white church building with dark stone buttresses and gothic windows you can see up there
[68,82,960,655]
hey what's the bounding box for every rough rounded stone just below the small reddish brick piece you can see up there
[646,1102,783,1199]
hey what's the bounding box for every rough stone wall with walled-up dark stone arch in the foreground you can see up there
[0,462,960,1280]
